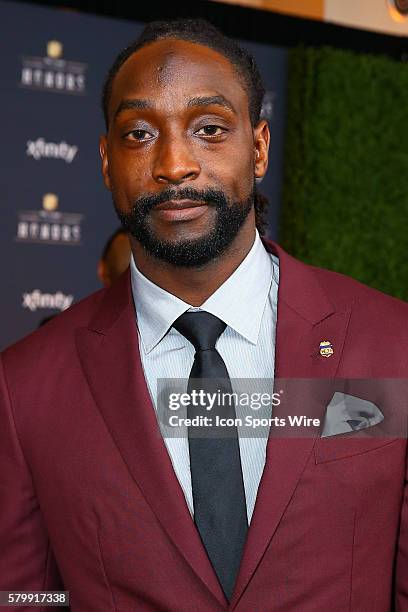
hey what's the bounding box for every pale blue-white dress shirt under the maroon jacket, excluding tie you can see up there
[131,230,279,523]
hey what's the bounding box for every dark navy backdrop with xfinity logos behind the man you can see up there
[0,2,286,349]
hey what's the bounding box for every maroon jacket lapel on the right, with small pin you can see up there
[230,240,350,610]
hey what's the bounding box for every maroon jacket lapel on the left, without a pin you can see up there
[76,271,226,605]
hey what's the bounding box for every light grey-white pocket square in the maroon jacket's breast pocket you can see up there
[321,391,384,438]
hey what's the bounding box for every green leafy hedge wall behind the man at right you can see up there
[280,48,408,300]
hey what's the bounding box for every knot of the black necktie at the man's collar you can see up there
[173,310,227,351]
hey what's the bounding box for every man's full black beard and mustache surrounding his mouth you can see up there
[112,182,256,268]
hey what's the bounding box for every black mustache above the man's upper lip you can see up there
[132,187,228,215]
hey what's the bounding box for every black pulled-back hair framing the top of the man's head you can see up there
[101,18,265,130]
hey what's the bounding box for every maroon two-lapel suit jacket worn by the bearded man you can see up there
[0,241,408,612]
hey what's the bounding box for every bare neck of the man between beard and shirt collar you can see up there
[131,225,255,306]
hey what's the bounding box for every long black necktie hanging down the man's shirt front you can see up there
[173,311,248,599]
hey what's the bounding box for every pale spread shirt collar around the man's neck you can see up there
[130,230,274,353]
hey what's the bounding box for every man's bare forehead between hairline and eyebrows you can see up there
[112,39,243,107]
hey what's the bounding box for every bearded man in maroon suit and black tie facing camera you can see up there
[0,16,408,612]
